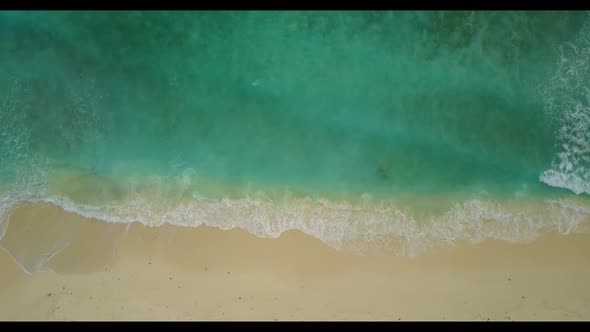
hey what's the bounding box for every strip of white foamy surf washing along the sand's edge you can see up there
[0,176,590,272]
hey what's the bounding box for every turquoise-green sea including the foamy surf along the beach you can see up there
[0,11,590,272]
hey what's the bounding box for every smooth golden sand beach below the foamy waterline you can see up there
[0,204,590,321]
